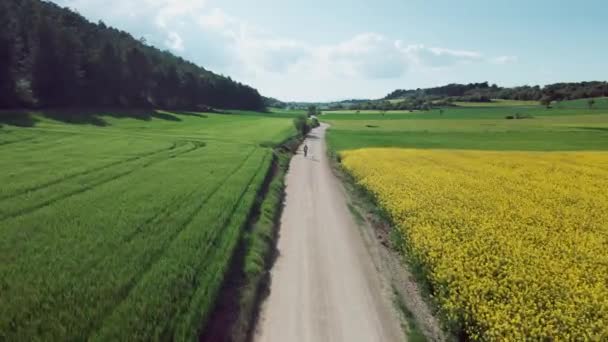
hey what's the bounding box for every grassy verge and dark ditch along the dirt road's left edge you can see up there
[199,122,310,342]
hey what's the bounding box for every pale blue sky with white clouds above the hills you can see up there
[53,0,608,101]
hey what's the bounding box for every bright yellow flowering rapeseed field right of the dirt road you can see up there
[342,149,608,341]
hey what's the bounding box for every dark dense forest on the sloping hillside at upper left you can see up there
[0,0,264,110]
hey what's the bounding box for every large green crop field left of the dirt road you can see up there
[0,111,295,340]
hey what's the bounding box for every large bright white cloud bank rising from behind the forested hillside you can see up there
[47,0,517,99]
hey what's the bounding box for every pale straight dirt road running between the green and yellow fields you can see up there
[255,125,405,342]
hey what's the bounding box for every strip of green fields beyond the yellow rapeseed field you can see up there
[323,99,608,151]
